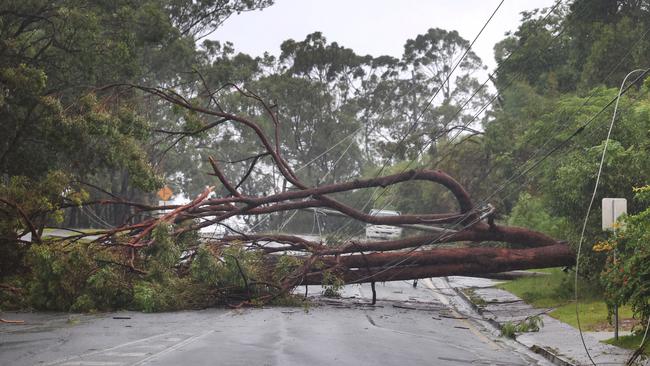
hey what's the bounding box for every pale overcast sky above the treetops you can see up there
[209,0,556,69]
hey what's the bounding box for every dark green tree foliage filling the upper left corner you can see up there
[0,0,272,234]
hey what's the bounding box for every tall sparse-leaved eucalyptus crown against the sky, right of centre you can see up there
[386,28,487,159]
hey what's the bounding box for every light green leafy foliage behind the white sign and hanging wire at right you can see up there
[485,81,650,282]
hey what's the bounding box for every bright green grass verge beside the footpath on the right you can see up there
[497,268,633,331]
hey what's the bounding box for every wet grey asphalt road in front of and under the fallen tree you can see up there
[0,281,546,366]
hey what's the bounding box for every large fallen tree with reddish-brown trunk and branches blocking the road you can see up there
[3,85,575,307]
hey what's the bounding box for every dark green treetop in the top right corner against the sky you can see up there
[495,0,650,93]
